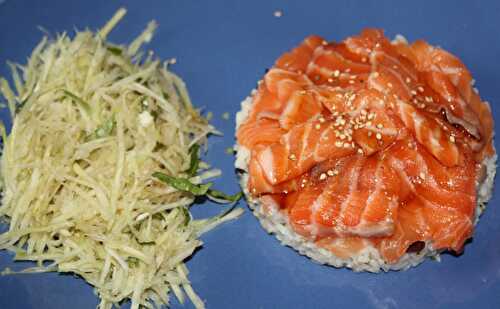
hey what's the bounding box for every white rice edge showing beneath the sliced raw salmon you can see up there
[235,97,497,273]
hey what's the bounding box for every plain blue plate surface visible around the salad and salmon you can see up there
[0,0,500,309]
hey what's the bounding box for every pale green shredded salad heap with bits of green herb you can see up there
[0,9,243,308]
